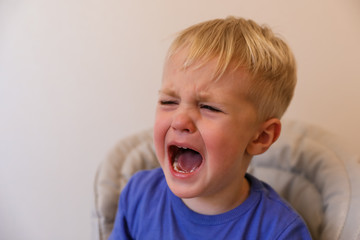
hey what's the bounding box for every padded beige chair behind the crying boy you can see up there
[92,121,360,240]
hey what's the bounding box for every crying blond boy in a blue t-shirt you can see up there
[110,17,311,240]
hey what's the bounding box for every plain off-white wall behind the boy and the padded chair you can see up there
[0,0,360,240]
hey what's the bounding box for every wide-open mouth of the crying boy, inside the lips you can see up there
[169,145,203,173]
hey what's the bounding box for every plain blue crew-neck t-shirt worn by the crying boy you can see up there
[109,168,311,240]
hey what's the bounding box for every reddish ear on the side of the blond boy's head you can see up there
[246,118,281,155]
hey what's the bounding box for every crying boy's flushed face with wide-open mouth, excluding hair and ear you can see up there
[154,49,258,207]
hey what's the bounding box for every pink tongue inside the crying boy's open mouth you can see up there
[176,150,202,172]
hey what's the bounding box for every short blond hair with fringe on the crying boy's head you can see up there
[168,17,297,120]
